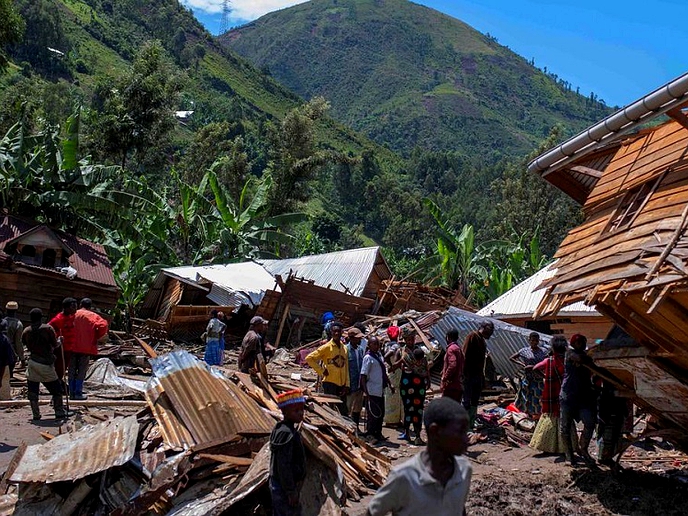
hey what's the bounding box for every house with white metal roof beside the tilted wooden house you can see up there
[477,262,614,341]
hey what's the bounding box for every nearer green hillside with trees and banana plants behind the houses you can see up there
[0,0,592,313]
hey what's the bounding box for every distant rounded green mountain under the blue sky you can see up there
[220,0,610,157]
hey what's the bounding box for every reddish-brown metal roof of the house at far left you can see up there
[0,215,117,287]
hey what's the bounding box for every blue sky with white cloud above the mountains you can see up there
[182,0,688,106]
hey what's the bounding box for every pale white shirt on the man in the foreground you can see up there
[368,453,473,516]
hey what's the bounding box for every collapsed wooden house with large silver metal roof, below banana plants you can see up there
[139,247,392,345]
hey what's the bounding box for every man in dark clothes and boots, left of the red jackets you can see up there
[22,308,68,421]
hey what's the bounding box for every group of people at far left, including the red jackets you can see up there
[0,297,108,420]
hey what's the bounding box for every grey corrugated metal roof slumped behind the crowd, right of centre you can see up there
[430,306,551,378]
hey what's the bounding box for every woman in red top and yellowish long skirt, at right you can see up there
[530,335,568,453]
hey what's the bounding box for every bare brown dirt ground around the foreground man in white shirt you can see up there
[346,429,688,516]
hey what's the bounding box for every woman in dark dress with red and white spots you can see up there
[393,329,430,446]
